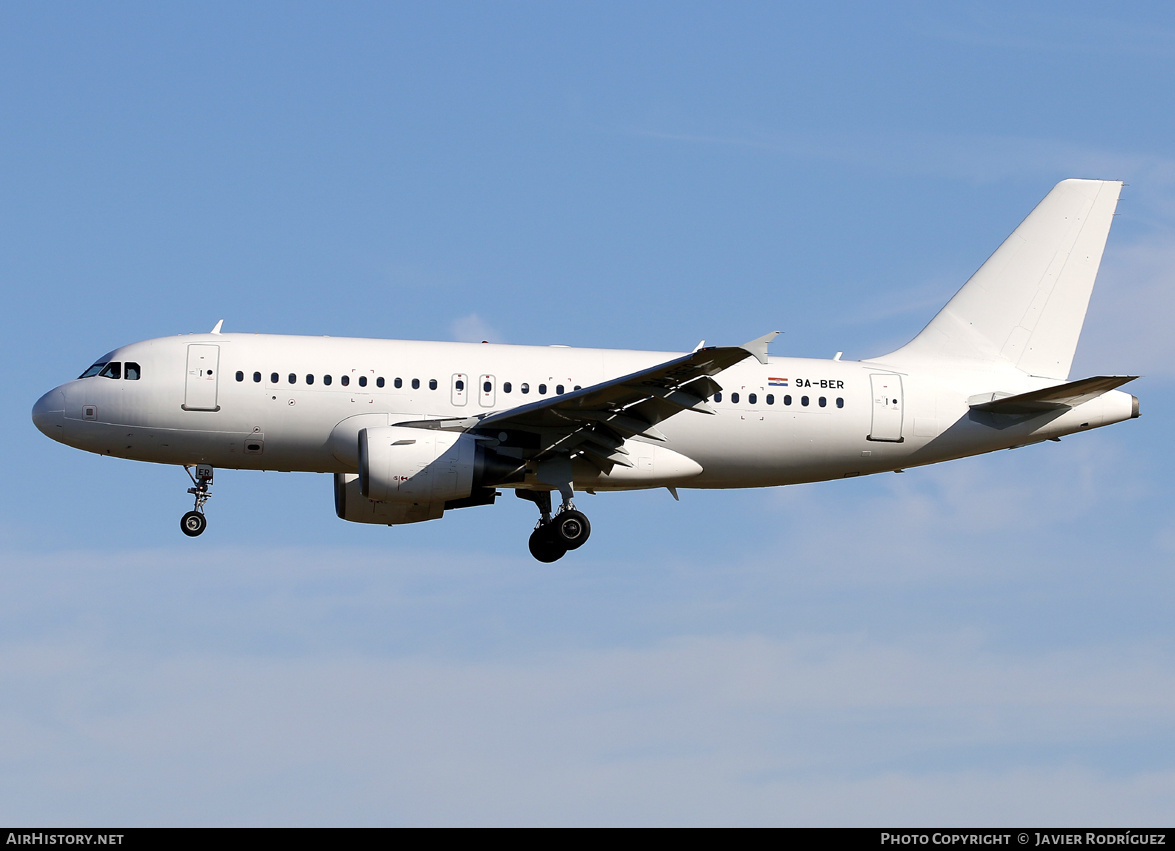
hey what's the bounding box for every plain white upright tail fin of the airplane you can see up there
[873,180,1122,380]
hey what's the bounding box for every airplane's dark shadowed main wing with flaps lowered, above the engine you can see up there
[397,331,779,474]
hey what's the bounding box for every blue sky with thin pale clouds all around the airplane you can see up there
[0,2,1175,825]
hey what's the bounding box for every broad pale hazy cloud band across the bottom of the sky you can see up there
[0,634,1175,824]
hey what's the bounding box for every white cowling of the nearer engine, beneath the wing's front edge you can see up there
[358,426,478,505]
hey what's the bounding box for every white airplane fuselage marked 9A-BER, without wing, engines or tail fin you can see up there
[34,334,1136,489]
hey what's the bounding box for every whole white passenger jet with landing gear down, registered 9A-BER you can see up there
[33,180,1139,562]
